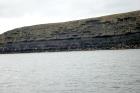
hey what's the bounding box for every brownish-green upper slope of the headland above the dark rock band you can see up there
[0,11,140,43]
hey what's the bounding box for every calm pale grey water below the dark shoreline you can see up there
[0,49,140,93]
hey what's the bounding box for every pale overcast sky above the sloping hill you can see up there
[0,0,140,34]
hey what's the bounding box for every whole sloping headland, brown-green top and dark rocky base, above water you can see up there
[0,11,140,53]
